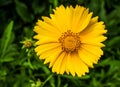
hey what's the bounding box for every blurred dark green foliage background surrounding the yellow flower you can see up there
[0,0,120,87]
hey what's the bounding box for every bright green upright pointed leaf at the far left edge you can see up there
[1,21,13,57]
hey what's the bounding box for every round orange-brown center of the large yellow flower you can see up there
[59,30,80,52]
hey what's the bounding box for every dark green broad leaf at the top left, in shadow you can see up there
[15,0,34,22]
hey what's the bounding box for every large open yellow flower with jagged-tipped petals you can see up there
[34,5,107,76]
